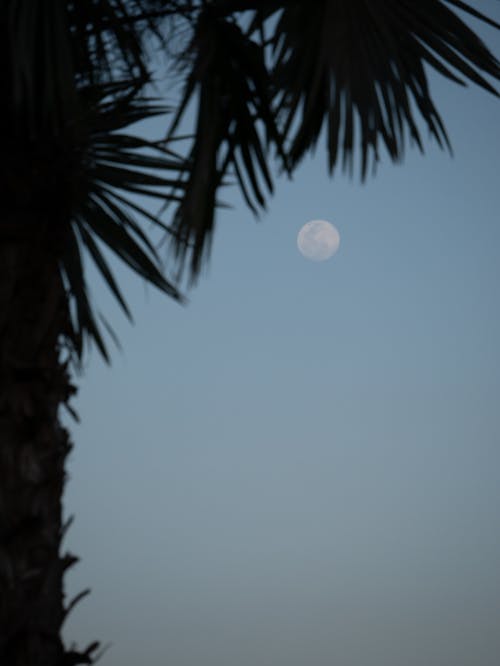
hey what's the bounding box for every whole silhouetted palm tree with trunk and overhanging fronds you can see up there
[0,0,500,666]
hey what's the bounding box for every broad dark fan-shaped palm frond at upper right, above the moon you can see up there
[267,0,500,178]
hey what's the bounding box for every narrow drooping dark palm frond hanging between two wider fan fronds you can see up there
[169,10,286,276]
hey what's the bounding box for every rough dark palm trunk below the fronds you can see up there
[0,226,91,666]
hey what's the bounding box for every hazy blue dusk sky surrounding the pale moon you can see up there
[65,5,500,666]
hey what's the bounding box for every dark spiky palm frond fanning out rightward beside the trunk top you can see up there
[61,83,186,358]
